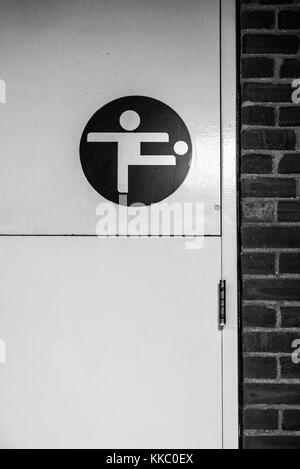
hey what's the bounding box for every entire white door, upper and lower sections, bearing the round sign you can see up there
[0,0,237,449]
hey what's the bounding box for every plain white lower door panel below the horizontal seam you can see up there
[0,237,222,448]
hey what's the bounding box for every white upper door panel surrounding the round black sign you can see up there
[0,0,220,235]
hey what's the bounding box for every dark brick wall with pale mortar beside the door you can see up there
[238,0,300,449]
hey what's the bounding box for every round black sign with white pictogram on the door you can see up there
[80,96,192,206]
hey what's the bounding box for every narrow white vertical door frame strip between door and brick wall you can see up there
[220,0,239,449]
